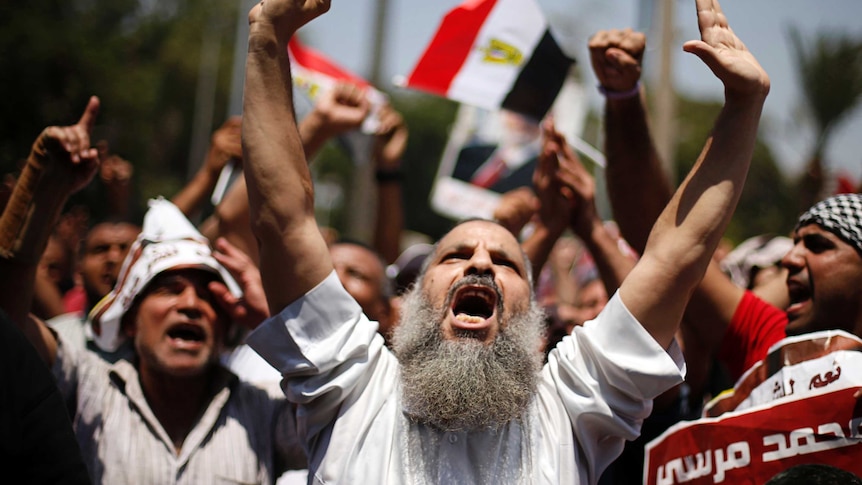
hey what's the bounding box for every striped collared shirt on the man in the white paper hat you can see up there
[53,338,306,485]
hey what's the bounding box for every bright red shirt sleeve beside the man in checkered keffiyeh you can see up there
[718,291,787,382]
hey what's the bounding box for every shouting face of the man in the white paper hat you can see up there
[125,269,227,381]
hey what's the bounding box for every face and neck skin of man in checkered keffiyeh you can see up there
[781,224,862,335]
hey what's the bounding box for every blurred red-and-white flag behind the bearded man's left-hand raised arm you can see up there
[287,36,386,133]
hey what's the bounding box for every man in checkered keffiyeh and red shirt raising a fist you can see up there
[590,21,862,396]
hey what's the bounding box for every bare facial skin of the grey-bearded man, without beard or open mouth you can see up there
[422,221,532,343]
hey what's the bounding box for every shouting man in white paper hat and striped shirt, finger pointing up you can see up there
[0,98,305,484]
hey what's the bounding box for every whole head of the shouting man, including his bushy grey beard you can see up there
[394,221,543,431]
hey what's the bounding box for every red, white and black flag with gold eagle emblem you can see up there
[403,0,574,120]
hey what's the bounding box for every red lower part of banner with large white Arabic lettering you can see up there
[644,388,862,485]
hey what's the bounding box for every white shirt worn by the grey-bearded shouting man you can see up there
[247,272,685,484]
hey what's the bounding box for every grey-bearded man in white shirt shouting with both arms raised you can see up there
[242,0,769,484]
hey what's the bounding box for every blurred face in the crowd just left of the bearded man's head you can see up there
[329,243,390,335]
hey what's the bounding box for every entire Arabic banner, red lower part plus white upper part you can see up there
[644,330,862,485]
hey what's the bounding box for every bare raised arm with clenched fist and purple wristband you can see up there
[590,23,742,348]
